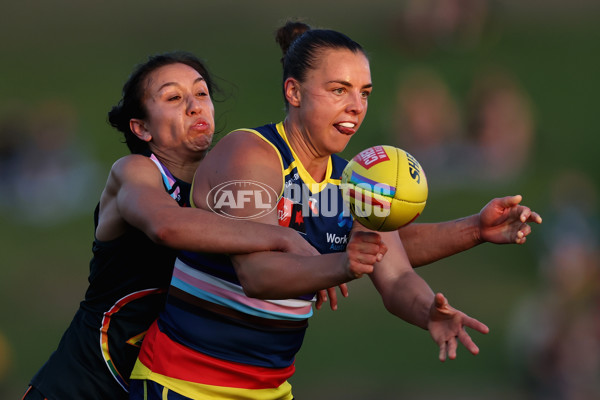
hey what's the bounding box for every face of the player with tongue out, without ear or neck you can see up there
[296,49,372,155]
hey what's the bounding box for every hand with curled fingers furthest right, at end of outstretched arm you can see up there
[479,195,542,244]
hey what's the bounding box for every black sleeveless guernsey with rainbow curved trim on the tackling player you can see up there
[31,154,191,400]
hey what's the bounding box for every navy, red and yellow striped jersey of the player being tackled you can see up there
[132,123,352,400]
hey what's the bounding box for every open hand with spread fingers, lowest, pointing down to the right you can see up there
[427,293,489,362]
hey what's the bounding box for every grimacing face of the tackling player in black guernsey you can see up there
[143,64,215,155]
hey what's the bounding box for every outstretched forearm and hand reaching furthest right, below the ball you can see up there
[398,195,542,267]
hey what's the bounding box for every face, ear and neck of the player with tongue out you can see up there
[284,49,373,181]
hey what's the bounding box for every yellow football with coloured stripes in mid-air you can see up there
[341,145,428,232]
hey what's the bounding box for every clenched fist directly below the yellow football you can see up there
[346,230,387,279]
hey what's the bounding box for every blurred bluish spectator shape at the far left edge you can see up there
[0,100,99,225]
